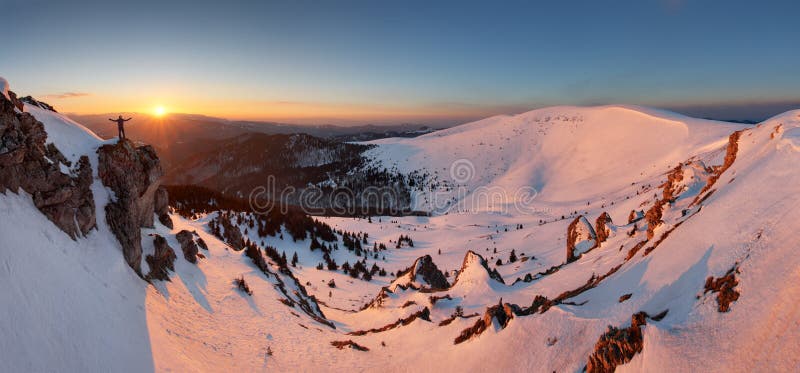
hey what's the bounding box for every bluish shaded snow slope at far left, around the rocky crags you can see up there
[0,79,153,371]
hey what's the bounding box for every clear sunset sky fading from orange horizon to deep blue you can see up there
[0,0,800,124]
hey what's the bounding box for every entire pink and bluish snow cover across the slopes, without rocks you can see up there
[0,82,800,372]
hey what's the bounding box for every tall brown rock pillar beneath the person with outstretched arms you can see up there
[97,140,163,275]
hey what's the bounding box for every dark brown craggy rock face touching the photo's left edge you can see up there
[0,92,96,239]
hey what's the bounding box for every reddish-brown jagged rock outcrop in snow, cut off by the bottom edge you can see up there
[586,312,647,373]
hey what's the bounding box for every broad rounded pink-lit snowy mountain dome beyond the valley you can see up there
[368,106,742,212]
